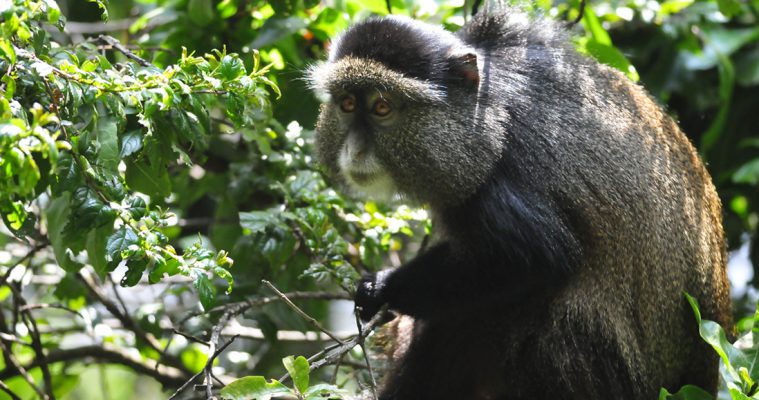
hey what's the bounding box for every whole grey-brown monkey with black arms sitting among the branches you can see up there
[310,9,730,400]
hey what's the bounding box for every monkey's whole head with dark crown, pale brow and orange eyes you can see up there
[309,17,503,207]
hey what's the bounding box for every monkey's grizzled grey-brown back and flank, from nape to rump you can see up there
[460,14,730,398]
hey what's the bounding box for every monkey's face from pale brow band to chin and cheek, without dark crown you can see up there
[311,58,501,206]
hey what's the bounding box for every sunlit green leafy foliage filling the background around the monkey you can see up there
[0,0,759,399]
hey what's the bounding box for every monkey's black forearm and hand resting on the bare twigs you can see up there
[355,239,548,319]
